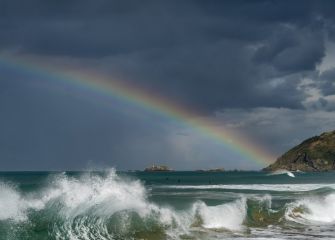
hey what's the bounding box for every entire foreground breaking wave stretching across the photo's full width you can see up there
[0,170,335,240]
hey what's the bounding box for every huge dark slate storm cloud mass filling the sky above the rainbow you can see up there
[0,0,335,112]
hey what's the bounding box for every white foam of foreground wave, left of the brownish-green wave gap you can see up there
[0,171,253,240]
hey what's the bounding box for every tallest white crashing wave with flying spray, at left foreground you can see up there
[0,170,197,239]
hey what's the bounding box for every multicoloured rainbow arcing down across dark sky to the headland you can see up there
[0,55,274,166]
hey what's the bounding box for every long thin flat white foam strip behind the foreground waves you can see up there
[156,183,335,192]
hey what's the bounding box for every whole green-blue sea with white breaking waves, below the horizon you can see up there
[0,169,335,240]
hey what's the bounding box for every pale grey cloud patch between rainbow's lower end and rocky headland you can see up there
[216,108,335,156]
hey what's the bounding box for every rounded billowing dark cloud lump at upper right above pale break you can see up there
[254,26,325,72]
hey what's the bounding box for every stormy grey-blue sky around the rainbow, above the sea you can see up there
[0,0,335,171]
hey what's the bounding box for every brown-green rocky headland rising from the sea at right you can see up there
[263,131,335,172]
